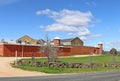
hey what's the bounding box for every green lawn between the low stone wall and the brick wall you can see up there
[36,55,120,63]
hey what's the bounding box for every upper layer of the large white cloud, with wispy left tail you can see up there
[36,9,92,27]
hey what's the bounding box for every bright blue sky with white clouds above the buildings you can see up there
[0,0,120,50]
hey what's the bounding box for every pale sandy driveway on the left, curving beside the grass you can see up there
[0,57,48,77]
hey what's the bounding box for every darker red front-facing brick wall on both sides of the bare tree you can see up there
[1,44,70,57]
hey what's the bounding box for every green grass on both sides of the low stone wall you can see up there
[13,56,120,73]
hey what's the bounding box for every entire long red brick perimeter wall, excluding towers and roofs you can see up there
[0,44,99,57]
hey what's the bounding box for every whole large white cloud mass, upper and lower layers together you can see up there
[36,9,100,39]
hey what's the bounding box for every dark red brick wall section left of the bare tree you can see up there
[3,44,41,57]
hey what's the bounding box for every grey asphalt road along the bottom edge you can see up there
[0,71,120,81]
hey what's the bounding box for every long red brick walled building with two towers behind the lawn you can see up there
[0,35,103,57]
